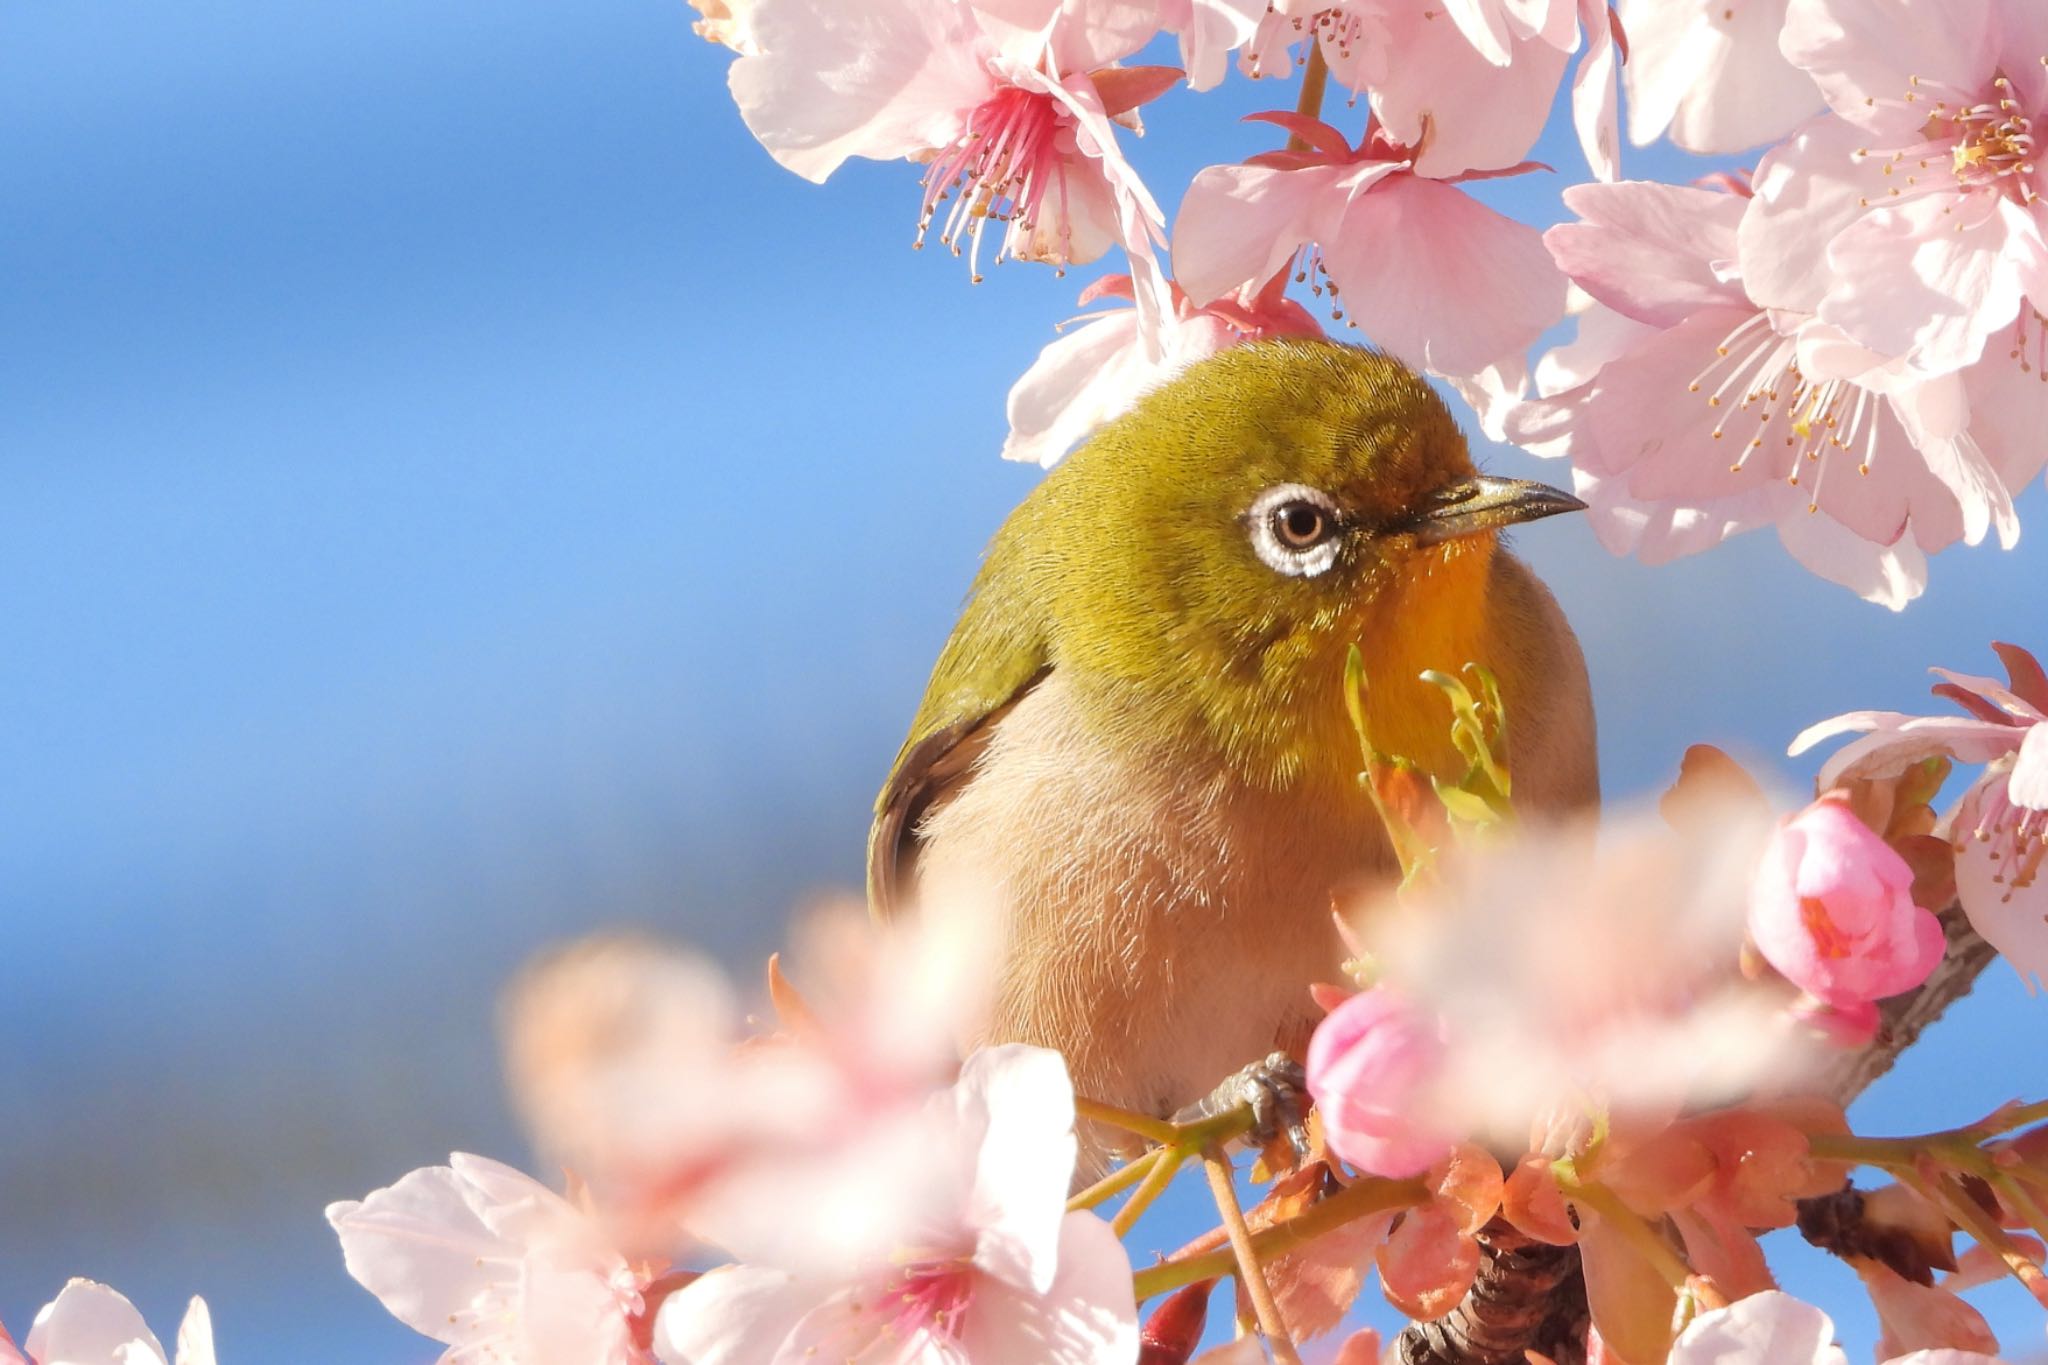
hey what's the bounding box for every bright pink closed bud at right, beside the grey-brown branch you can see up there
[1749,796,1946,1031]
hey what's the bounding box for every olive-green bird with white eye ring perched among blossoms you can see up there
[868,338,1599,1171]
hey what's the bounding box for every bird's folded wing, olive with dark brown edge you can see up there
[868,591,1053,919]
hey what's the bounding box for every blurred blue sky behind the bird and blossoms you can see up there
[0,0,2048,1365]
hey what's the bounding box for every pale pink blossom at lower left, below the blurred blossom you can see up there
[328,1152,657,1365]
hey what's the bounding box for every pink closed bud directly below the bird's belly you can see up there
[1309,986,1450,1179]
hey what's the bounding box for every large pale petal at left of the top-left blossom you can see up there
[727,0,995,180]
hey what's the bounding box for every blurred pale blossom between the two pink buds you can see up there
[1350,802,1815,1150]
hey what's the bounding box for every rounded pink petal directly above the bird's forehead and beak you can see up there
[1323,176,1565,375]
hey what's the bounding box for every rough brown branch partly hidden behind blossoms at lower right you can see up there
[1397,905,1997,1365]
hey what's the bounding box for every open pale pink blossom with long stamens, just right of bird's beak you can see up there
[1505,182,2017,608]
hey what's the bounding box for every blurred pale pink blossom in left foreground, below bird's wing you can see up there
[504,907,991,1265]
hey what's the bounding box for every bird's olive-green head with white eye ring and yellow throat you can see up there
[1006,340,1583,784]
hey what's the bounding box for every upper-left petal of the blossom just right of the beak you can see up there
[1544,180,1747,327]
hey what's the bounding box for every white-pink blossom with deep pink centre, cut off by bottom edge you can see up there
[655,1046,1139,1365]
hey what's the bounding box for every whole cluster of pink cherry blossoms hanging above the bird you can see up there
[698,0,2048,608]
